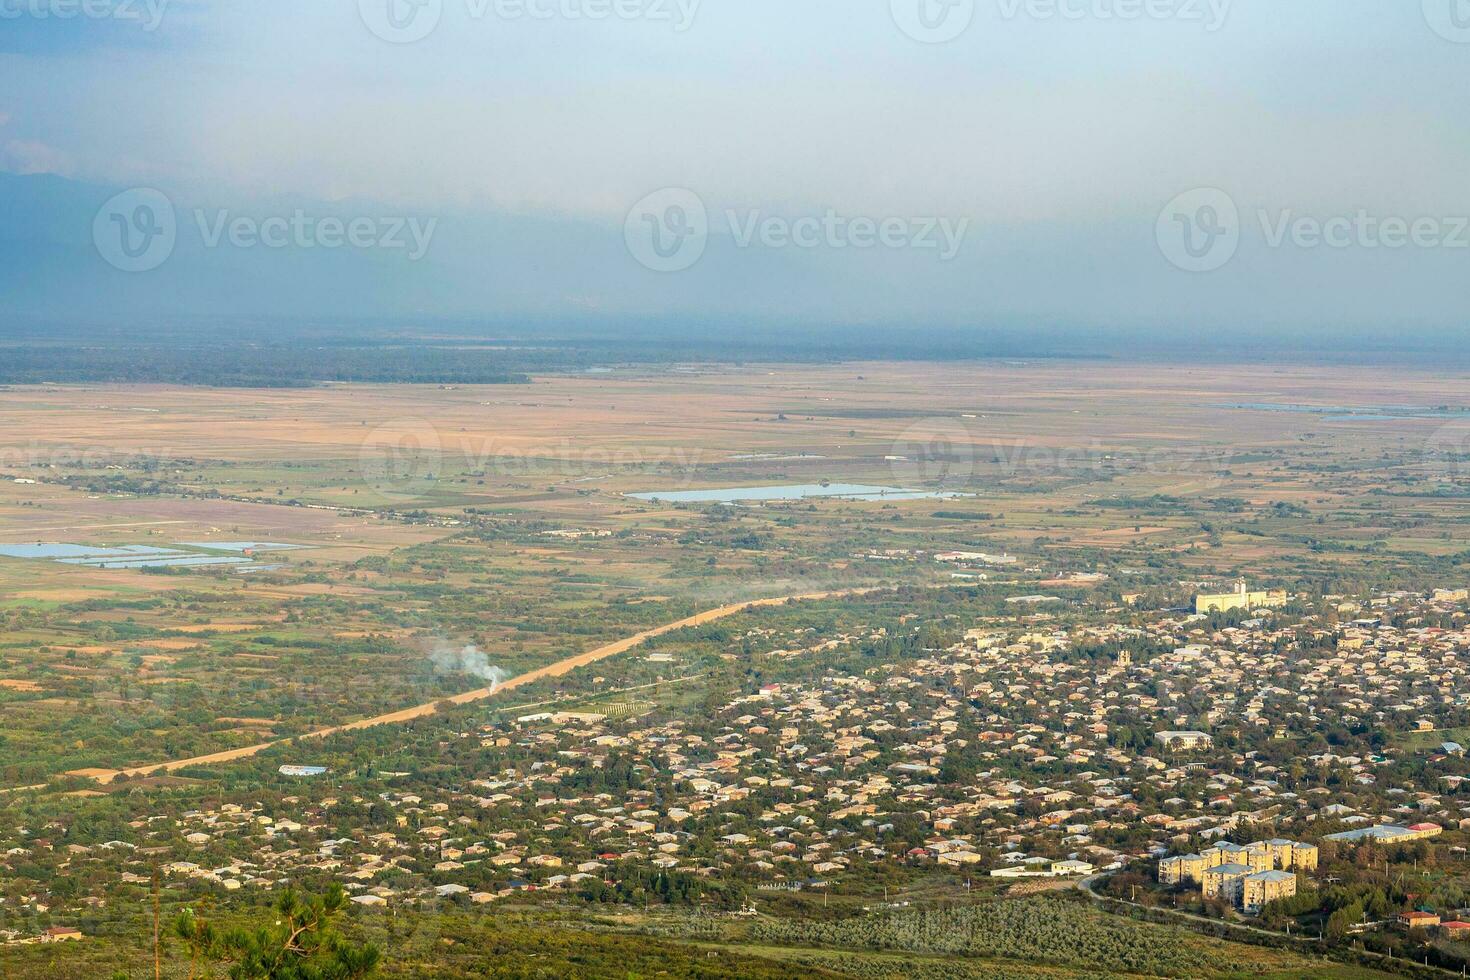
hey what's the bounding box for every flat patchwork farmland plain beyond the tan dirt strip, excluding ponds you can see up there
[0,361,1470,786]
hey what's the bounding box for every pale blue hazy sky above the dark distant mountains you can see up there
[0,0,1470,326]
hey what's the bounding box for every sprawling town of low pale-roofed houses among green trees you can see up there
[0,589,1470,942]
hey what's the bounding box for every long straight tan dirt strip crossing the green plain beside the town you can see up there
[85,588,878,783]
